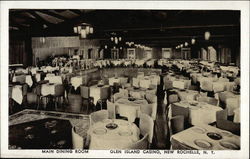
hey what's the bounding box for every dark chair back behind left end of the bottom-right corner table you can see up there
[170,115,184,135]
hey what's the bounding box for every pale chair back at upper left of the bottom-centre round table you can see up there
[90,110,109,125]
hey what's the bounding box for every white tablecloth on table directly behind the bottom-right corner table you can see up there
[169,101,222,125]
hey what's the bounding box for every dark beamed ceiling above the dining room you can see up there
[9,9,240,47]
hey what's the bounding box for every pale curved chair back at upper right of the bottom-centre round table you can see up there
[139,113,154,144]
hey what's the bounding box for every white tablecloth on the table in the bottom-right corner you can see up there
[171,125,240,150]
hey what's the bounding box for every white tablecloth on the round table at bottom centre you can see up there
[88,119,140,150]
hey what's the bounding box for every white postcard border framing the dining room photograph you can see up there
[0,1,250,158]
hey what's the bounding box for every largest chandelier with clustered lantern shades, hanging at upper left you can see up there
[74,23,94,39]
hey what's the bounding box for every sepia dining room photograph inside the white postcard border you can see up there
[8,9,241,150]
